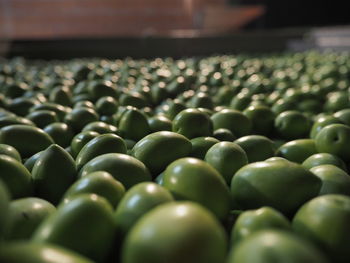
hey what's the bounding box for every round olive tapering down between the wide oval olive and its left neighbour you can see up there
[204,142,248,184]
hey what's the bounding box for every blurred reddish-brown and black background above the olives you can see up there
[0,0,350,58]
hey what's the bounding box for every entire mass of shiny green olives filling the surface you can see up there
[0,51,350,263]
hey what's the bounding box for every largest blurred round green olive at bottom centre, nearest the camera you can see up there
[121,202,227,263]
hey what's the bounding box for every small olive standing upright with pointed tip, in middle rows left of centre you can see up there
[118,107,150,141]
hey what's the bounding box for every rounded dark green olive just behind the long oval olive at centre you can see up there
[173,109,213,139]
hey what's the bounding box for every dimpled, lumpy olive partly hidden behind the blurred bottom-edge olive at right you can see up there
[231,206,291,246]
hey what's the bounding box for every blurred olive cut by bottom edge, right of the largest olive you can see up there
[227,230,330,263]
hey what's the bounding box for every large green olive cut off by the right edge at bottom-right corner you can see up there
[292,195,350,263]
